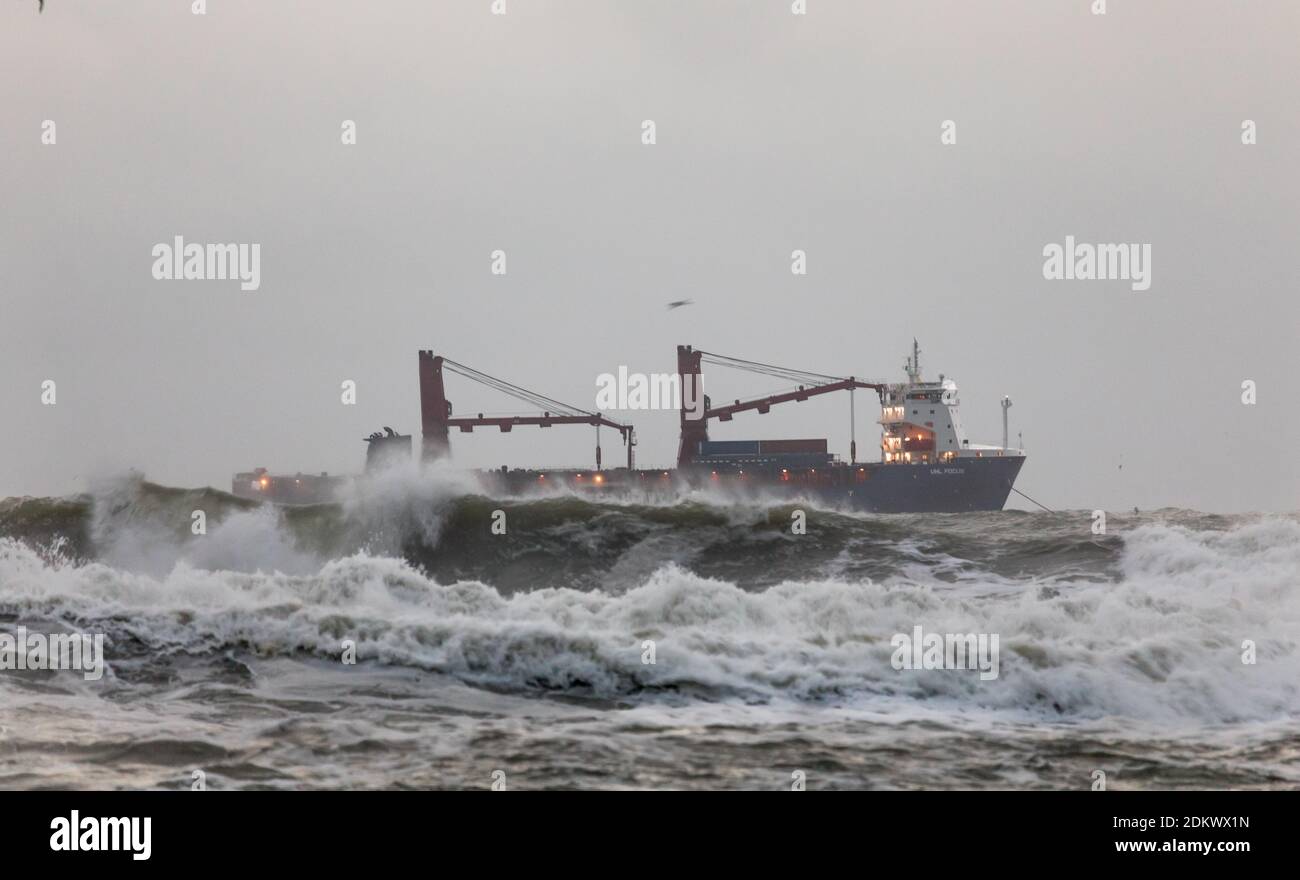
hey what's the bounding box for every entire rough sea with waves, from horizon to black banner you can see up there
[0,472,1300,789]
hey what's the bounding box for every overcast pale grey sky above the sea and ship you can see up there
[0,0,1300,511]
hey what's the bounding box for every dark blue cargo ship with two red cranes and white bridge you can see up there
[231,341,1024,513]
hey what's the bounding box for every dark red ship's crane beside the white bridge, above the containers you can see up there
[677,346,885,468]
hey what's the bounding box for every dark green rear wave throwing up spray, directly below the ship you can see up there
[0,468,1138,593]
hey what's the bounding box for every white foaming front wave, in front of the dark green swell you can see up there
[0,520,1300,723]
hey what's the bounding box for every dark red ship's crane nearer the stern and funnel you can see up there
[420,351,637,471]
